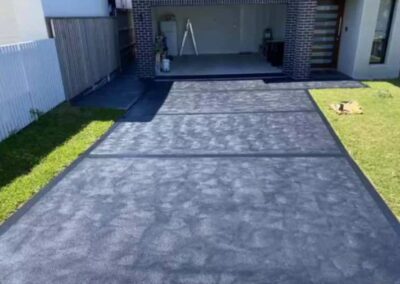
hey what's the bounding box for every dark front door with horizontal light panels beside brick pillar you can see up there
[311,0,344,68]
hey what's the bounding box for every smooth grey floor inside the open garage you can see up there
[156,54,282,77]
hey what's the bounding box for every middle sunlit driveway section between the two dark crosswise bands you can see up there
[92,112,339,155]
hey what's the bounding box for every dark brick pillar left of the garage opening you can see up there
[132,0,155,78]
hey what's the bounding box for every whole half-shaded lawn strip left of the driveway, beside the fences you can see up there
[0,104,122,224]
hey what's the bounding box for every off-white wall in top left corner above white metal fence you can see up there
[0,0,48,44]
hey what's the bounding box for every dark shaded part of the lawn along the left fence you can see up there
[0,104,121,191]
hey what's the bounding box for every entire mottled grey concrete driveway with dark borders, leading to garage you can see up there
[0,81,400,284]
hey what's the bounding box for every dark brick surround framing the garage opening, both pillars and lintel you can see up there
[132,0,317,80]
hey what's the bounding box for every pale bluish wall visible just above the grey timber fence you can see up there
[42,0,109,17]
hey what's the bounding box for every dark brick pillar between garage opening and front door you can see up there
[283,0,317,80]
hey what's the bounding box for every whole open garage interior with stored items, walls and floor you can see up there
[152,4,287,77]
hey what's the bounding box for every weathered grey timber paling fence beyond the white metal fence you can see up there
[48,17,120,99]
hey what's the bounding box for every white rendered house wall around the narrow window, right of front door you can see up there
[338,0,400,79]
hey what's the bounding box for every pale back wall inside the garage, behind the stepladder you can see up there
[153,4,286,54]
